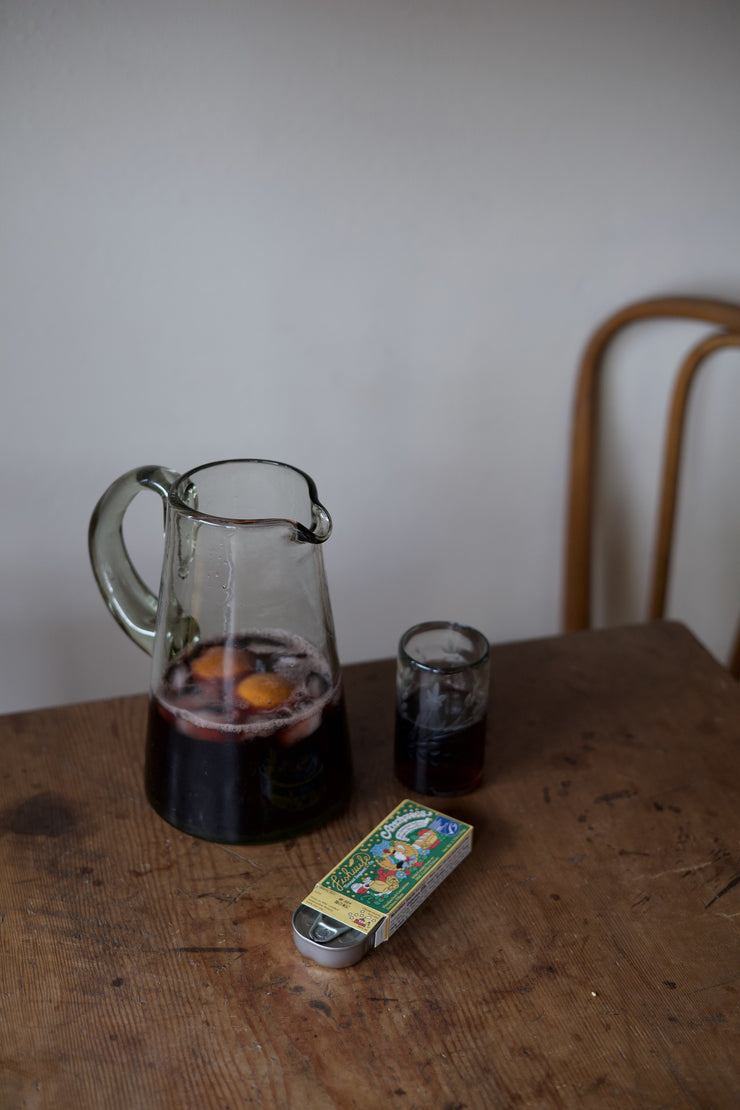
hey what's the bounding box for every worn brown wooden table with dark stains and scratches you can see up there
[0,624,740,1110]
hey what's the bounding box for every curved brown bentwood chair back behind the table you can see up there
[564,296,740,678]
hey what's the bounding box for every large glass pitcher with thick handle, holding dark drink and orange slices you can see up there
[90,458,351,844]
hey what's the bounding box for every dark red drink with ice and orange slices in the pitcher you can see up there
[145,629,352,844]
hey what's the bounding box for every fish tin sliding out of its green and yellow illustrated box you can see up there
[293,798,473,968]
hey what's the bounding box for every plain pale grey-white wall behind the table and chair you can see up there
[0,0,740,710]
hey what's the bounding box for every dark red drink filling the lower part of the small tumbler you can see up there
[394,697,486,798]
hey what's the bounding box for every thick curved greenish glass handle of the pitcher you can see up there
[88,466,179,655]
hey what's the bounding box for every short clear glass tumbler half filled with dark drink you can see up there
[394,620,489,798]
